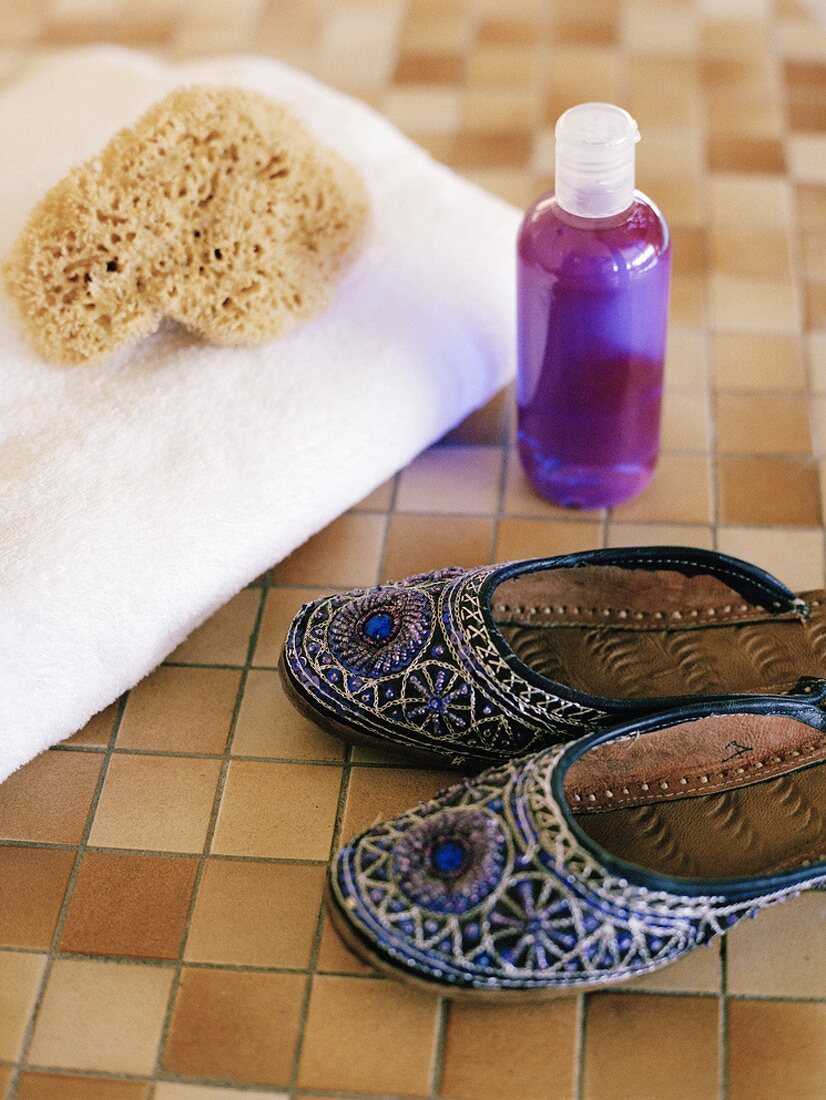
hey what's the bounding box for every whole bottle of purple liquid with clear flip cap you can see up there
[517,103,671,508]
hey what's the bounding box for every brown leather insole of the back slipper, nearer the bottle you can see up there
[493,565,826,699]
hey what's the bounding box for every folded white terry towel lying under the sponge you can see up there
[0,47,518,780]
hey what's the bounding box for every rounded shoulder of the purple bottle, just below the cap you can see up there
[517,191,671,277]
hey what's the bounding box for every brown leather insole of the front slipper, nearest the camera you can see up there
[565,715,826,879]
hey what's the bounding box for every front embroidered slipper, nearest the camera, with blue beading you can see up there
[327,699,826,1000]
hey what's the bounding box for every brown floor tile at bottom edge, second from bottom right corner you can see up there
[440,997,580,1100]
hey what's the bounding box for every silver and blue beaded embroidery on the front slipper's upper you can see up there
[331,748,826,989]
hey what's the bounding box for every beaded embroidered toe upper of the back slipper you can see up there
[285,567,606,763]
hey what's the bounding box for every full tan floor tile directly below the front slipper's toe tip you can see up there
[298,976,439,1096]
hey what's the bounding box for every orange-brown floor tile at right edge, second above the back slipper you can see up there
[717,455,821,527]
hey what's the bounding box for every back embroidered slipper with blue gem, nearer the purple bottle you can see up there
[279,547,826,767]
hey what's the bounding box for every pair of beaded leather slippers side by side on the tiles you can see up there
[280,547,826,1000]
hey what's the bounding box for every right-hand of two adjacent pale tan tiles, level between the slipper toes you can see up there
[212,760,341,859]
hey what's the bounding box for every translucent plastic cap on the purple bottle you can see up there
[554,103,640,218]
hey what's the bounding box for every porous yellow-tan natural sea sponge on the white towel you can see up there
[2,87,367,364]
